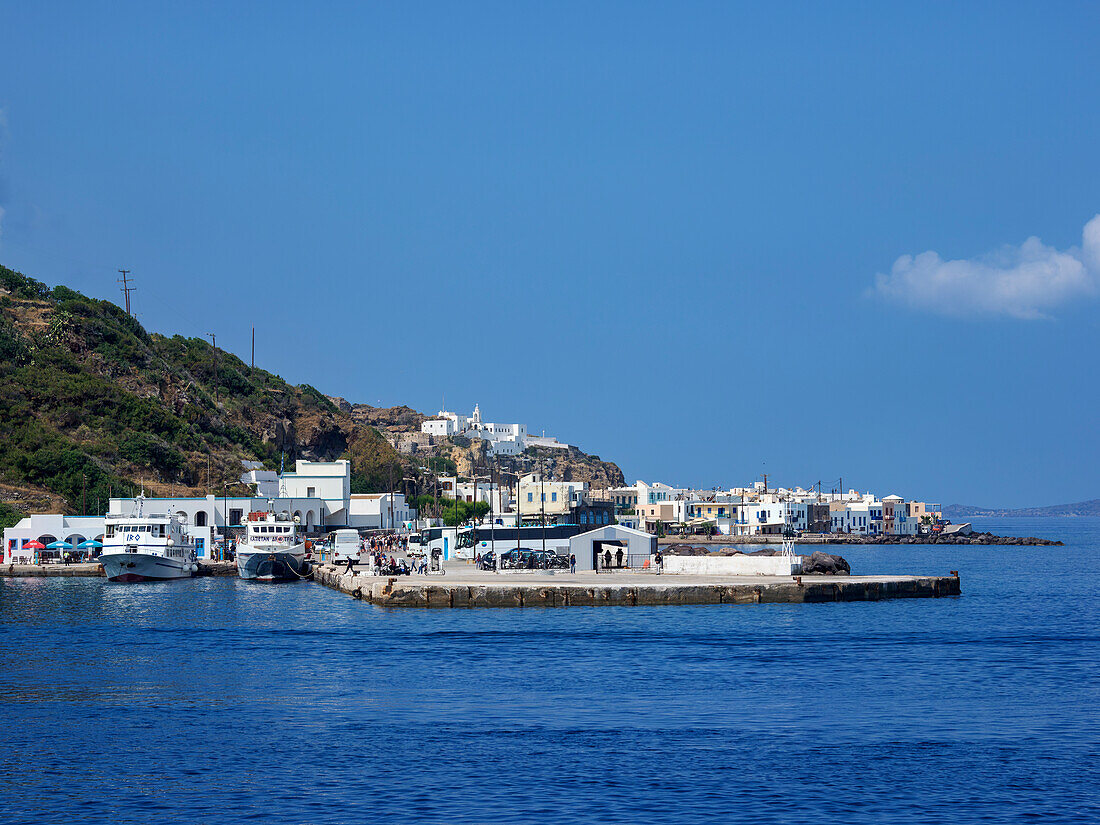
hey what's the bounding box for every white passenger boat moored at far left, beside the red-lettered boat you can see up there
[99,495,198,582]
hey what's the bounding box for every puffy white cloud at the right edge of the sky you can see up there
[872,215,1100,319]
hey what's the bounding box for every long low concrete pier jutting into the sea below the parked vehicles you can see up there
[314,565,961,607]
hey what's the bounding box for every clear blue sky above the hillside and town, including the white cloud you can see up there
[0,2,1100,506]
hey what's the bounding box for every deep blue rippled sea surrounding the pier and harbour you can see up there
[0,519,1100,824]
